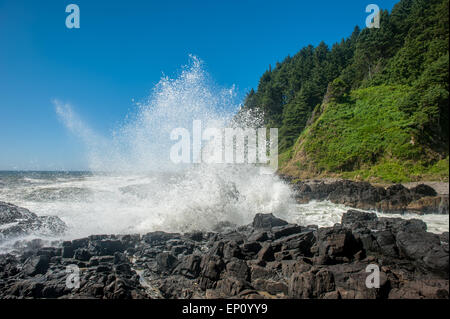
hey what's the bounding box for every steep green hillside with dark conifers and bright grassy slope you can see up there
[244,0,449,182]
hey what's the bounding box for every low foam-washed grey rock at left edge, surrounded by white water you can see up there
[0,202,66,243]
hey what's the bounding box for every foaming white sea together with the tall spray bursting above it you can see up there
[0,57,449,252]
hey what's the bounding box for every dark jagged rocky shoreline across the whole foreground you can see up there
[0,203,449,299]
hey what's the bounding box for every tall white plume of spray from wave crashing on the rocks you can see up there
[47,57,295,235]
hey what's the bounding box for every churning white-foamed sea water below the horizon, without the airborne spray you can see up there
[0,171,449,249]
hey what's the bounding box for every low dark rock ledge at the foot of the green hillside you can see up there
[284,180,449,214]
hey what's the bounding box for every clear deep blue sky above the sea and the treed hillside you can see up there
[0,0,397,170]
